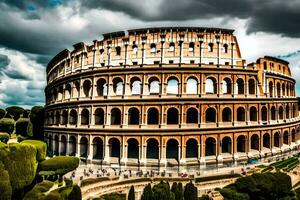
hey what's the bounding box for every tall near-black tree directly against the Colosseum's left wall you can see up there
[29,106,45,140]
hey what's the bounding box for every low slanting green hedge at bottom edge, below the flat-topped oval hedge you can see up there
[23,180,54,200]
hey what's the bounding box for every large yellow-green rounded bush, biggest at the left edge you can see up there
[0,143,37,199]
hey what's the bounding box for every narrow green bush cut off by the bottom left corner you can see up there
[0,162,12,200]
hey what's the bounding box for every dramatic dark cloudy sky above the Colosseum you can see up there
[0,0,300,107]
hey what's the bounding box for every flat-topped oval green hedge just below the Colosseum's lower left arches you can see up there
[39,156,79,175]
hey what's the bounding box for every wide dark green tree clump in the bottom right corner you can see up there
[220,172,294,200]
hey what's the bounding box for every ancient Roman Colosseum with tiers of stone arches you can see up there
[45,27,300,168]
